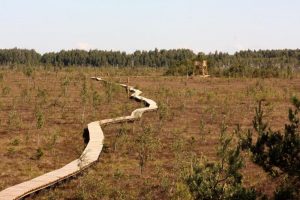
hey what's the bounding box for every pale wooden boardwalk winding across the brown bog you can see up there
[0,77,158,200]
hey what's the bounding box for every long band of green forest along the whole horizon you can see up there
[0,48,300,76]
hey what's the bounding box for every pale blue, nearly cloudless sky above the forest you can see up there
[0,0,300,53]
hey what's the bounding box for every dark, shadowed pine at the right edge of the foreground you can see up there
[241,97,300,199]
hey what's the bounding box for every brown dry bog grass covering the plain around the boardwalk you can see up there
[0,66,300,199]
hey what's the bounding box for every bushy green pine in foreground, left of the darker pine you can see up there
[185,122,257,200]
